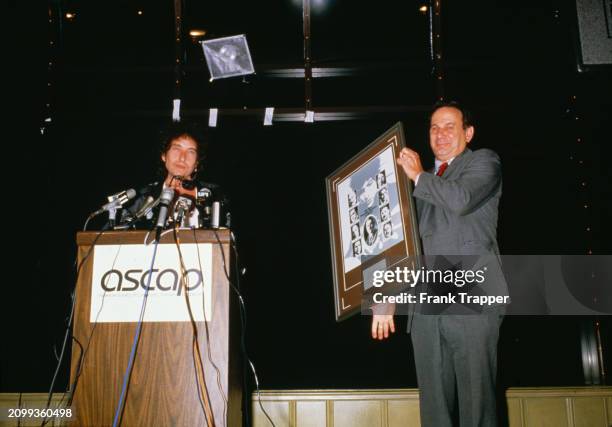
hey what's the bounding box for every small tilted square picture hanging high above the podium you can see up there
[200,34,255,81]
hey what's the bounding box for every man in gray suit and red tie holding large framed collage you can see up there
[372,102,507,427]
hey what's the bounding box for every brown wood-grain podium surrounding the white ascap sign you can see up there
[70,230,242,427]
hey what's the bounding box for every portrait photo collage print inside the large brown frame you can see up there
[338,147,404,272]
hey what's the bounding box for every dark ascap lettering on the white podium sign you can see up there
[100,268,203,295]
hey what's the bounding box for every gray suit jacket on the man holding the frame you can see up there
[412,148,508,318]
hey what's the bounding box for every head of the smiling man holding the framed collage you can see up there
[429,107,474,162]
